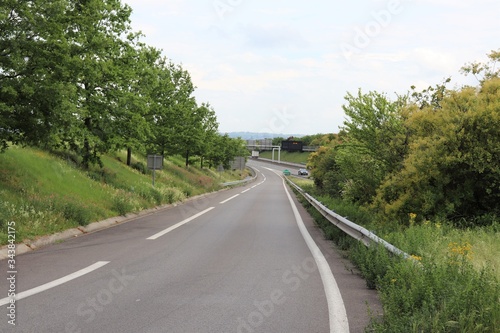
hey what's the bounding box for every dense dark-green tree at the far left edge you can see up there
[0,0,77,149]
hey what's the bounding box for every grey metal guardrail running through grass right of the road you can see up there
[284,177,411,259]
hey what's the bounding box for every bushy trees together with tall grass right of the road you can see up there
[288,52,500,333]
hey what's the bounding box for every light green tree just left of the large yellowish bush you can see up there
[335,90,408,203]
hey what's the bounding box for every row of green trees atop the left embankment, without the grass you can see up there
[0,0,242,167]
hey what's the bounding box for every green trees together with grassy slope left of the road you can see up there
[0,0,247,244]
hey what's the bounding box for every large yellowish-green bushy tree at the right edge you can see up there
[373,77,500,220]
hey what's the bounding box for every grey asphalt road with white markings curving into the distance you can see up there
[0,161,380,333]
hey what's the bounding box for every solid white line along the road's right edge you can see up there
[283,180,349,333]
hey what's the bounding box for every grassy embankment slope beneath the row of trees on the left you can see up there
[0,147,250,245]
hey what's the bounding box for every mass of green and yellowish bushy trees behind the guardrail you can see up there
[309,52,500,226]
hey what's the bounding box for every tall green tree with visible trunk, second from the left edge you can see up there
[65,0,137,167]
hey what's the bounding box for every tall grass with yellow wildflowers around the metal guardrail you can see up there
[291,177,500,333]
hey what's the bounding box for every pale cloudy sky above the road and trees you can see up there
[122,0,500,135]
